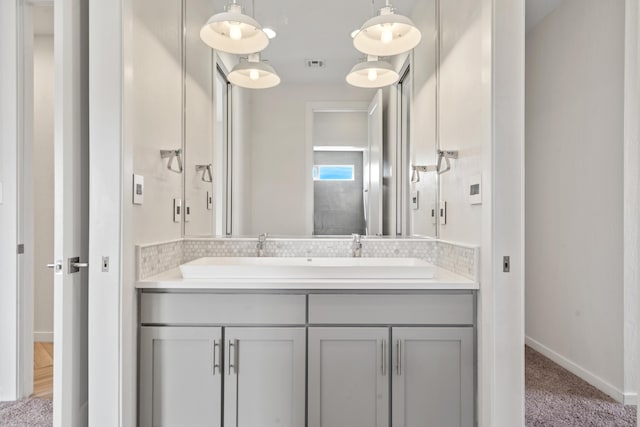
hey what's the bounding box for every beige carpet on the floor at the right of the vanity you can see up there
[525,347,636,427]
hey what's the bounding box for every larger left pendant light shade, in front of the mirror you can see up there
[200,2,269,55]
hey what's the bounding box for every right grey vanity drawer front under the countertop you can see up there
[309,293,474,325]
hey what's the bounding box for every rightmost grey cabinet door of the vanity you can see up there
[392,328,475,427]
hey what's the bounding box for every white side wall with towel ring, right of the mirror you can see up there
[438,0,490,244]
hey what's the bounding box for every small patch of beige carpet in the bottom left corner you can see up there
[0,399,53,427]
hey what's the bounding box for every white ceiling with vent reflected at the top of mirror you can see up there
[210,0,426,83]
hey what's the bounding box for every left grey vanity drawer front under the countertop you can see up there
[140,293,306,325]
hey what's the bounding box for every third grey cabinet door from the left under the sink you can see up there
[308,327,389,427]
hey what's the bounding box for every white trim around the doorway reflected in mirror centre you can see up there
[304,101,369,236]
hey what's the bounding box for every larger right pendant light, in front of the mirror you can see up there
[353,0,422,56]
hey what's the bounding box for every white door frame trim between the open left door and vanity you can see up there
[88,0,124,426]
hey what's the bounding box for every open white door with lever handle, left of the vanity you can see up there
[53,0,89,427]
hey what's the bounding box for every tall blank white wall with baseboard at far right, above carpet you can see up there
[526,0,637,400]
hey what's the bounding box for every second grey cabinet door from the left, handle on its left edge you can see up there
[224,327,305,427]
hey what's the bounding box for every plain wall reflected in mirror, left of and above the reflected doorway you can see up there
[247,83,373,235]
